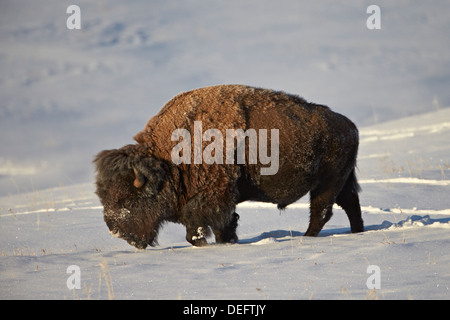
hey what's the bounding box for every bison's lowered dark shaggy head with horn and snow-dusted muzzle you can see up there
[94,145,170,249]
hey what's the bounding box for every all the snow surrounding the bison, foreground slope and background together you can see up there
[0,0,450,299]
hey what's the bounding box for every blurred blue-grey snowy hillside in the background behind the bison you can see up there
[0,0,450,195]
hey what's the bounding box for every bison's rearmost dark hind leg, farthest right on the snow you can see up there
[336,170,364,233]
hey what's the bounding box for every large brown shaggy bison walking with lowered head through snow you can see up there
[94,85,364,249]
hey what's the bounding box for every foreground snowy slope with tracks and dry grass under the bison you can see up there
[0,109,450,299]
